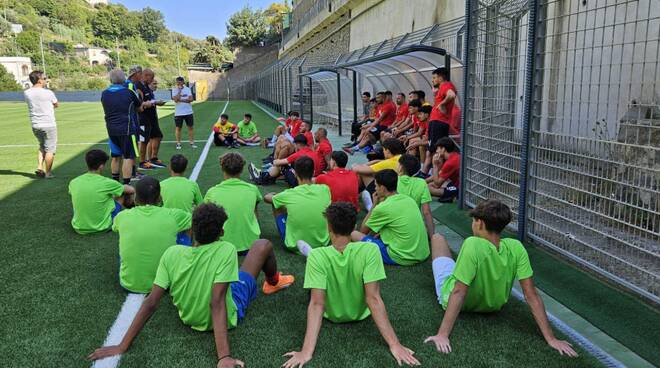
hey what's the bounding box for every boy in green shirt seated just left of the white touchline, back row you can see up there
[160,154,202,245]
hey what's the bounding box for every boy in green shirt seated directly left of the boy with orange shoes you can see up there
[112,176,191,294]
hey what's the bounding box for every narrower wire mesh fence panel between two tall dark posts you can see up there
[461,0,529,227]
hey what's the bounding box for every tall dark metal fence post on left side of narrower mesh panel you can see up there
[458,0,472,209]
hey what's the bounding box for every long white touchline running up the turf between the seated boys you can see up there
[92,100,229,368]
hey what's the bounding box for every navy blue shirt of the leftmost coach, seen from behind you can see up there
[101,84,140,136]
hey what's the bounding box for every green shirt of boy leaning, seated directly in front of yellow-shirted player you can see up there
[366,194,430,266]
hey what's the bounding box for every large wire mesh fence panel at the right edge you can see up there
[528,0,660,301]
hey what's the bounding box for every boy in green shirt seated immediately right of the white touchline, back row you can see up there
[204,152,263,255]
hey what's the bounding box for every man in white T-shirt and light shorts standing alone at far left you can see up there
[24,70,58,179]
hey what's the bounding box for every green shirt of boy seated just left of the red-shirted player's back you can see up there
[273,184,330,253]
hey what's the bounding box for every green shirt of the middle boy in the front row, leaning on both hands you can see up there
[304,242,385,322]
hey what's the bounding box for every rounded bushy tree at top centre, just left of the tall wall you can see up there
[225,6,268,48]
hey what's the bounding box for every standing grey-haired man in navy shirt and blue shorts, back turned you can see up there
[101,69,153,184]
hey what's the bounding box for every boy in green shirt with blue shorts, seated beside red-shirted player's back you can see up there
[264,156,330,255]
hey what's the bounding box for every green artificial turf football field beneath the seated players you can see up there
[0,101,599,368]
